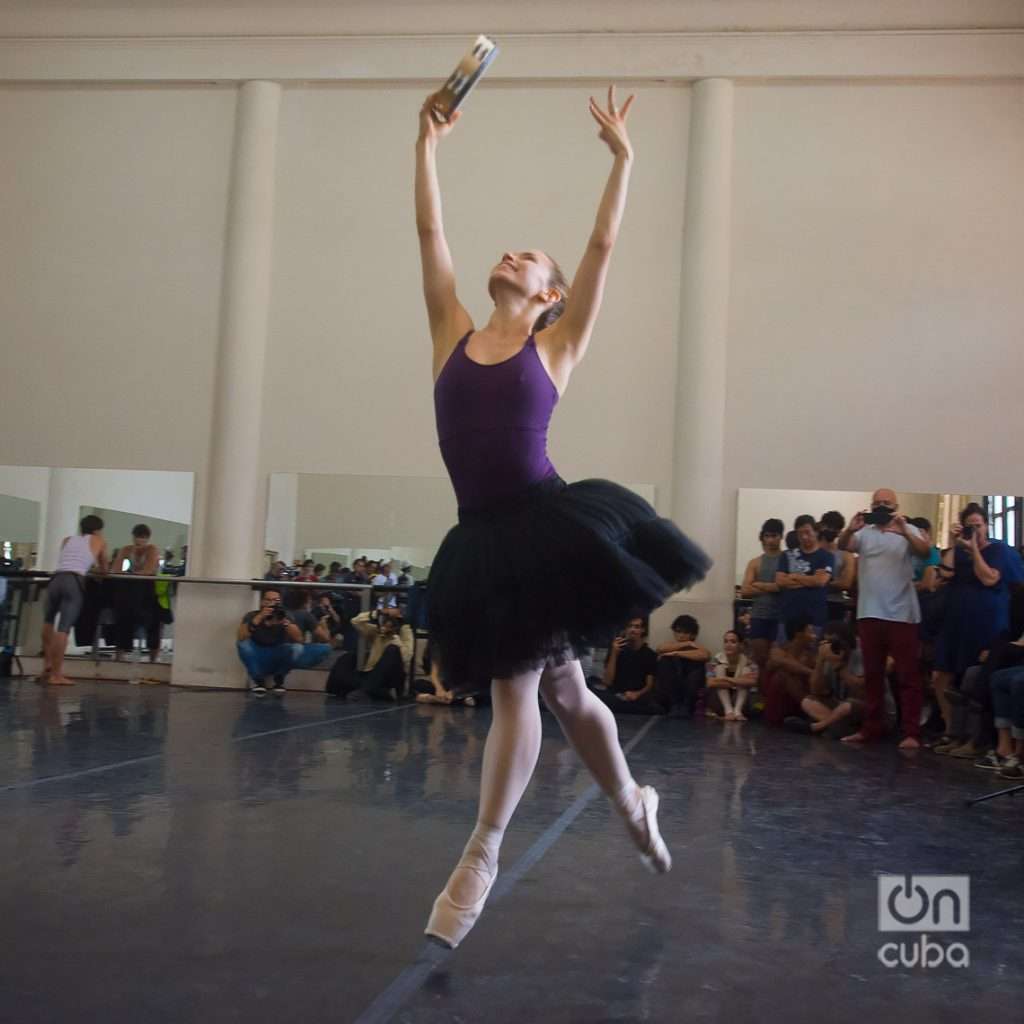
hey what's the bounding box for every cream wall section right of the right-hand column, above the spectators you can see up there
[722,83,1024,593]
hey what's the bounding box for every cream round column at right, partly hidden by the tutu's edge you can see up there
[672,79,735,630]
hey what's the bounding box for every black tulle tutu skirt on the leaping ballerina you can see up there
[427,476,711,690]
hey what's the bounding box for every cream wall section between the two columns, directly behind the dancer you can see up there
[263,84,689,512]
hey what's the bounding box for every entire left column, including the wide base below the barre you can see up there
[171,82,281,687]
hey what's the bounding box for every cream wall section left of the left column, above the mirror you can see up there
[0,85,234,471]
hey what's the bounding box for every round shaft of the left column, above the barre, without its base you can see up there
[199,82,281,577]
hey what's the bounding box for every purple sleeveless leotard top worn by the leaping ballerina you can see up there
[434,332,558,511]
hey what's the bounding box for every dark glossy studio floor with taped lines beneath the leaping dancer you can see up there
[0,680,1024,1024]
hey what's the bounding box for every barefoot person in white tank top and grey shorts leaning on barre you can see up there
[39,515,108,686]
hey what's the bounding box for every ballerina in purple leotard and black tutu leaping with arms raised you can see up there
[416,83,710,947]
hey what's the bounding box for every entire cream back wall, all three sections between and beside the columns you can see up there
[0,56,1024,610]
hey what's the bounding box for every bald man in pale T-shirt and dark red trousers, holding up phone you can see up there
[839,487,931,750]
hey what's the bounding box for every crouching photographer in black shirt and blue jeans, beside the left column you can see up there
[238,590,331,697]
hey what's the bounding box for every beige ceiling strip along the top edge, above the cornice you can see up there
[0,0,1024,38]
